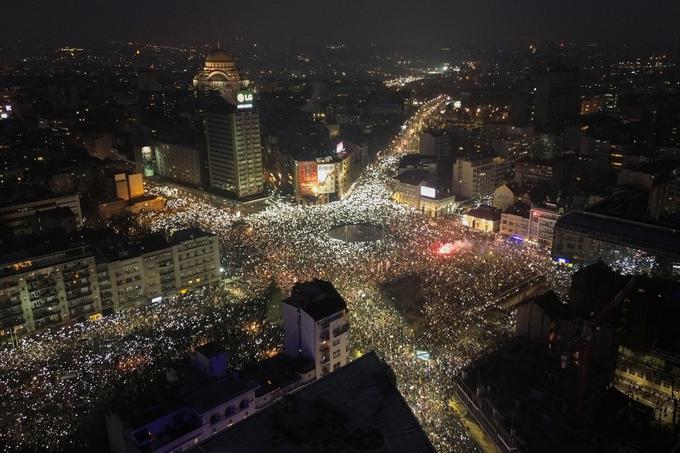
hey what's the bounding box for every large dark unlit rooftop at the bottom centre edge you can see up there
[193,352,435,453]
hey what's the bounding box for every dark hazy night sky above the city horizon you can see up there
[5,0,680,45]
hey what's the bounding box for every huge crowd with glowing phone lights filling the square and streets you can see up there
[0,97,569,451]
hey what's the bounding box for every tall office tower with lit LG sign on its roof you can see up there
[205,97,264,198]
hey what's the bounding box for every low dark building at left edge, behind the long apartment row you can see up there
[0,194,83,235]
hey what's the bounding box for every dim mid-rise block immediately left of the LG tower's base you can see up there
[155,142,206,188]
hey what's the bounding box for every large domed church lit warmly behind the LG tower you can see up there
[194,49,246,103]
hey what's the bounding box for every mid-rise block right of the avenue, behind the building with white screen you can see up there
[453,157,508,200]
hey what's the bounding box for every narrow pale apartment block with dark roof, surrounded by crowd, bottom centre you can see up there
[282,280,350,378]
